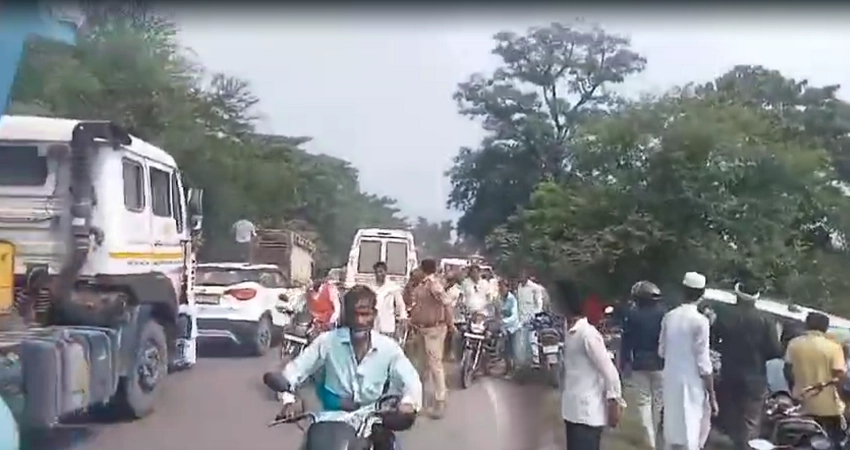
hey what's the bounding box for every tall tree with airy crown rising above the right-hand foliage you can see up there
[448,21,646,241]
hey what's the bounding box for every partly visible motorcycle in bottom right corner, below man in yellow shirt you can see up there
[748,380,847,450]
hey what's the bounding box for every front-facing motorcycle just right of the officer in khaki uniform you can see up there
[460,313,504,389]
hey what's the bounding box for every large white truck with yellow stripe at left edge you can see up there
[0,116,202,428]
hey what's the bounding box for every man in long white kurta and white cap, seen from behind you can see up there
[658,272,717,450]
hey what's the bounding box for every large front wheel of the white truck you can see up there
[118,320,168,419]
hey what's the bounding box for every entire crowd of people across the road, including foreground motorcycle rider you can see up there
[270,259,847,450]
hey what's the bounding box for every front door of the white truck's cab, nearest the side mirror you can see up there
[147,160,185,274]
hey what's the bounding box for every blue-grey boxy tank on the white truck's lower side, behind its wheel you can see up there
[0,327,118,428]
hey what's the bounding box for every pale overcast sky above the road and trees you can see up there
[172,7,850,220]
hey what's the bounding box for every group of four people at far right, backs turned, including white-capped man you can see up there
[612,272,847,450]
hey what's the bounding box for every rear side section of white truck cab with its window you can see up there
[119,154,153,270]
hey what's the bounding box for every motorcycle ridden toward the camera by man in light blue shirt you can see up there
[268,388,410,450]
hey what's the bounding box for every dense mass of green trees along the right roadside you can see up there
[449,20,850,313]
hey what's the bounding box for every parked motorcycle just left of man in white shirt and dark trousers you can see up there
[531,312,564,389]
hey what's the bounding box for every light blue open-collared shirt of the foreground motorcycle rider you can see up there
[283,327,422,420]
